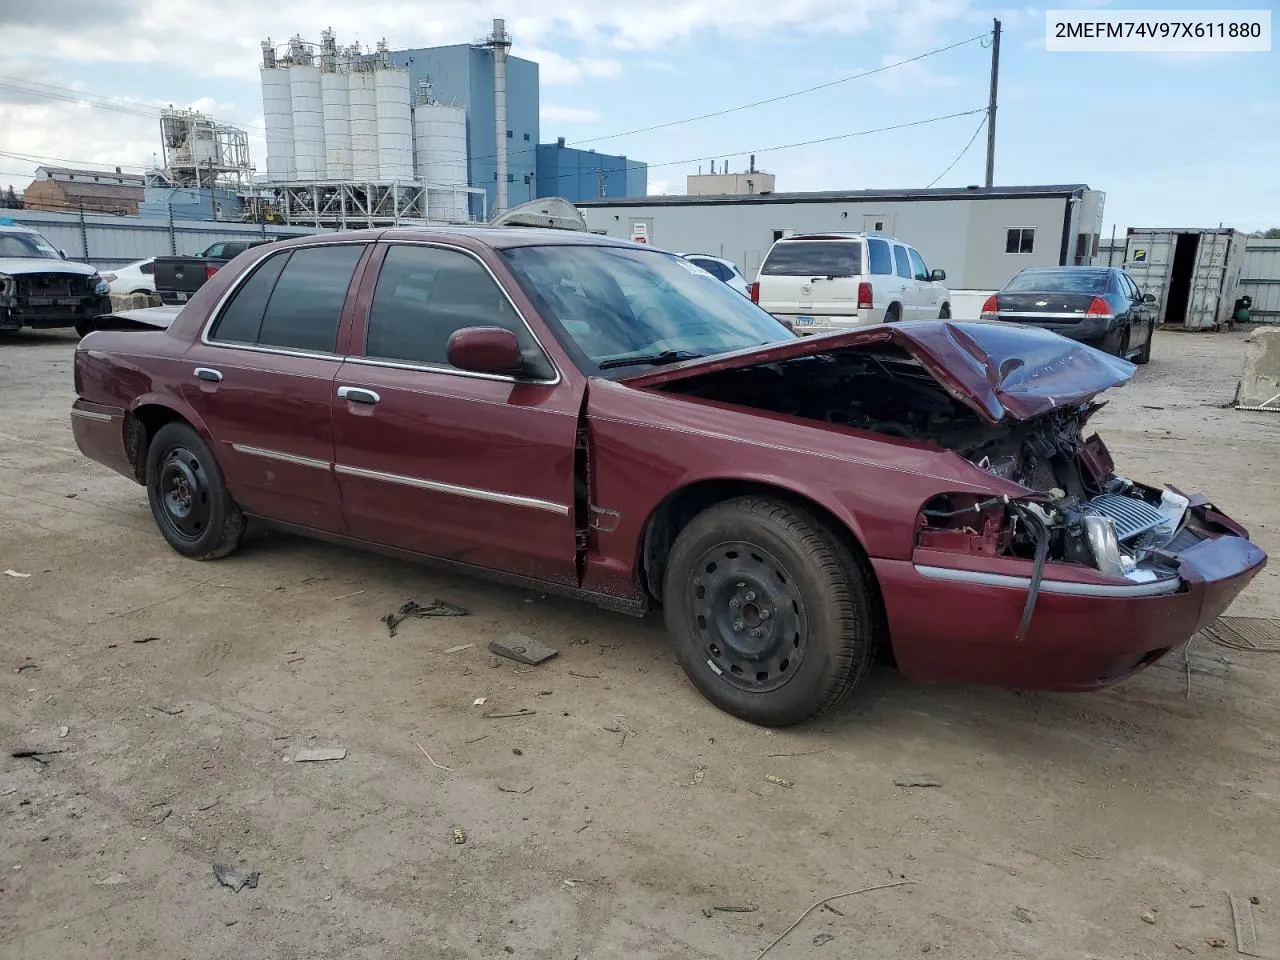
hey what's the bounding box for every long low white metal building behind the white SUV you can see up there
[577,183,1106,291]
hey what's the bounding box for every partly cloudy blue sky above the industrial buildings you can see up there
[0,0,1280,234]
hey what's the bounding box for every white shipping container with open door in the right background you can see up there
[1124,227,1245,330]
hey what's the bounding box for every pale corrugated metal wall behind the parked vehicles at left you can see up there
[0,210,324,268]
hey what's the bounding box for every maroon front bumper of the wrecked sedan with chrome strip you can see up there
[873,534,1267,690]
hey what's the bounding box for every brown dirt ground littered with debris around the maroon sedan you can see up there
[0,333,1280,960]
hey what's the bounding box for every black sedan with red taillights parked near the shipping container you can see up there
[982,266,1156,364]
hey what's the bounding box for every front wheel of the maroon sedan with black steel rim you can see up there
[663,497,879,727]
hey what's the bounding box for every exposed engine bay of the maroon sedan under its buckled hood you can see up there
[667,344,1212,582]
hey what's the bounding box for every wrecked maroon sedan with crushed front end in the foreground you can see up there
[72,228,1266,724]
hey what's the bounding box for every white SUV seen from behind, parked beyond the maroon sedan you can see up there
[751,233,951,333]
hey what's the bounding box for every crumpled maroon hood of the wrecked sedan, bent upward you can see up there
[618,320,1137,422]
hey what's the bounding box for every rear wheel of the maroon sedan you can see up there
[147,422,244,561]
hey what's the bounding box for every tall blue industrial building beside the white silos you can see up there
[390,44,538,214]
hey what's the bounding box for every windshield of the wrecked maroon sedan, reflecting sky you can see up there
[502,244,796,374]
